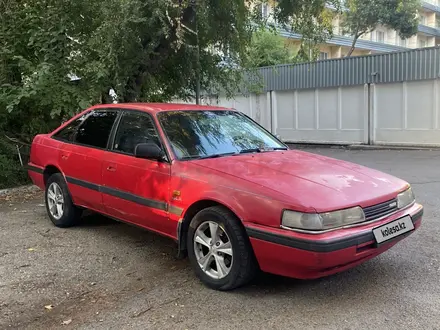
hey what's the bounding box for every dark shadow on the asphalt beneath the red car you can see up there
[73,211,399,297]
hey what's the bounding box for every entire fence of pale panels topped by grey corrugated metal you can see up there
[174,47,440,146]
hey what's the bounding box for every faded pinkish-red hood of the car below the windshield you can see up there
[195,150,408,212]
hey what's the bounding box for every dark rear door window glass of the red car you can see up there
[75,111,118,149]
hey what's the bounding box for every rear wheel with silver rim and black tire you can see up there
[44,173,82,228]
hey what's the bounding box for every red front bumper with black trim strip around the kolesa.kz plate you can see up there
[246,204,423,279]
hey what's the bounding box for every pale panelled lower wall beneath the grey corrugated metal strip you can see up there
[177,79,440,146]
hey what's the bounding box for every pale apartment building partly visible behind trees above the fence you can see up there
[261,0,440,60]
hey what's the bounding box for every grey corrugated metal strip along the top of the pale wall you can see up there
[258,47,440,91]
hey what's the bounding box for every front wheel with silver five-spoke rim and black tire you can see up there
[187,206,258,291]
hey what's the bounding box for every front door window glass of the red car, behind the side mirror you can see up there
[113,112,161,155]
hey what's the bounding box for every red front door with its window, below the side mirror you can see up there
[101,111,176,237]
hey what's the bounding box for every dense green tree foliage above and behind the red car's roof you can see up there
[0,0,334,187]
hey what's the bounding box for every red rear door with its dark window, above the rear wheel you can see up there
[59,109,119,211]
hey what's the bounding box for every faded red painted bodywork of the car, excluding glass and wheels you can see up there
[29,103,422,279]
